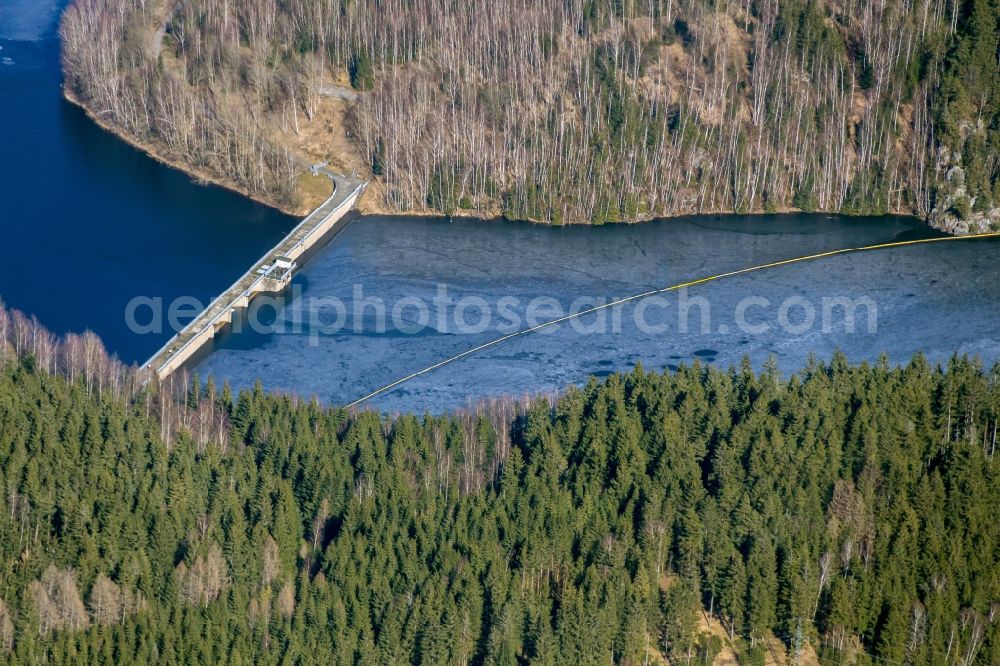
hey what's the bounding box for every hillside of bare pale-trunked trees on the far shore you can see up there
[62,0,1000,232]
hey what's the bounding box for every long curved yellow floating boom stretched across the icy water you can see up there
[347,232,1000,408]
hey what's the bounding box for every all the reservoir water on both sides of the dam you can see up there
[0,0,1000,412]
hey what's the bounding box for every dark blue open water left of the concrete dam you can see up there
[0,14,296,362]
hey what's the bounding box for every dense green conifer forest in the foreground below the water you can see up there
[0,302,1000,666]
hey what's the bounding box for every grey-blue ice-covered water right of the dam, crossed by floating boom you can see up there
[196,215,1000,412]
